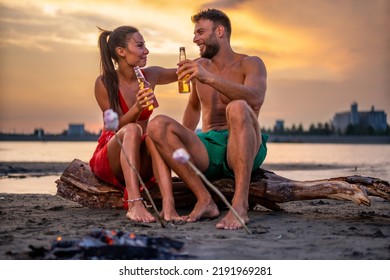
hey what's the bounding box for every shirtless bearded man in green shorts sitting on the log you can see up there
[148,9,267,229]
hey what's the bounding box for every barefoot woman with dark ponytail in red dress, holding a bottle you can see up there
[90,26,179,222]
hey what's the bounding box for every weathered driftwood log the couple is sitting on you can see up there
[56,159,390,211]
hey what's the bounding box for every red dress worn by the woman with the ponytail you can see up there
[89,91,155,209]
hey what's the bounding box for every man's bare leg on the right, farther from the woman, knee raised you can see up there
[216,101,261,229]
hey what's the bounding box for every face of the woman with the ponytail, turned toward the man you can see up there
[125,32,149,67]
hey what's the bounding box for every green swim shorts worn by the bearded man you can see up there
[197,129,268,179]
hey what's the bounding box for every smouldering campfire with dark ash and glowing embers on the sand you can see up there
[30,230,189,260]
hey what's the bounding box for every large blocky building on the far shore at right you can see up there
[333,102,387,133]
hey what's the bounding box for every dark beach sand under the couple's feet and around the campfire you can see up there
[0,162,390,260]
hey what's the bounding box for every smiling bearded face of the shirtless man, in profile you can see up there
[193,19,220,59]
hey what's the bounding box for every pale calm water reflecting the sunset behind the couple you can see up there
[0,142,390,194]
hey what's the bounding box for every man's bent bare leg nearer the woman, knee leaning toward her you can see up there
[148,115,219,222]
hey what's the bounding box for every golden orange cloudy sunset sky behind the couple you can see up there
[0,0,390,133]
